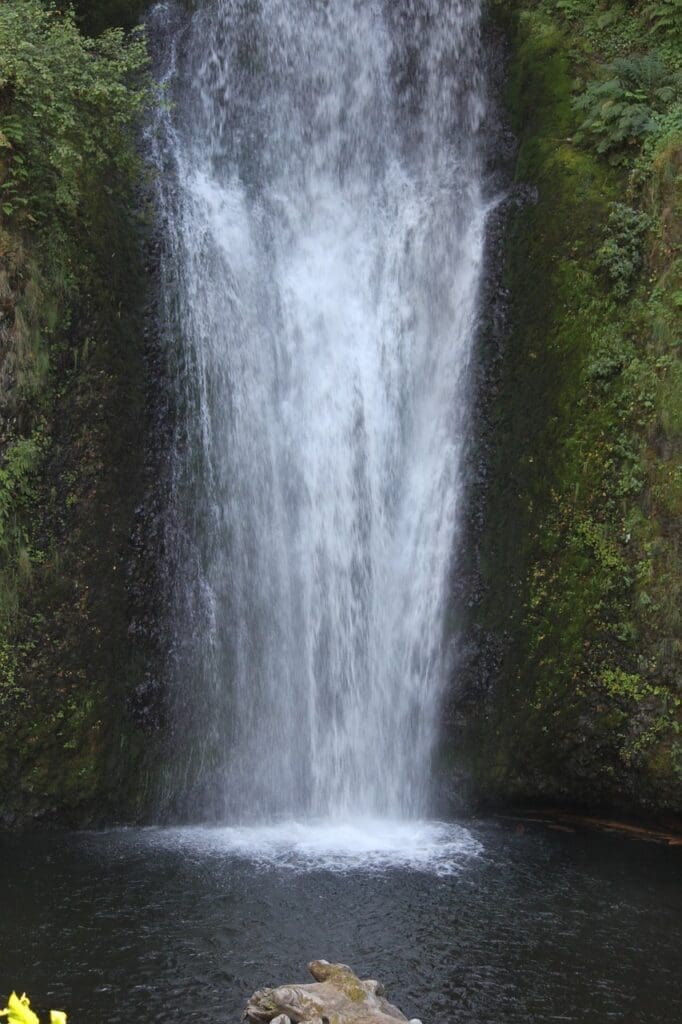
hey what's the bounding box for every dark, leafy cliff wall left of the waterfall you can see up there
[0,0,159,824]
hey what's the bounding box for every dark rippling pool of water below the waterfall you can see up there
[0,823,682,1024]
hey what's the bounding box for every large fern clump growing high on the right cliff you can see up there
[573,53,682,164]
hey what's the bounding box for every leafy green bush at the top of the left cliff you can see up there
[0,0,150,224]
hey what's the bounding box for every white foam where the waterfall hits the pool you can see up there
[133,818,482,876]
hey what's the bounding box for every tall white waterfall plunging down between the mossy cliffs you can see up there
[151,0,486,819]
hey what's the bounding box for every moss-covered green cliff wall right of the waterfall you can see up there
[446,0,682,814]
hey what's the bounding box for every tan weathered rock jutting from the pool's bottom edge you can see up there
[244,961,420,1024]
